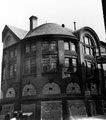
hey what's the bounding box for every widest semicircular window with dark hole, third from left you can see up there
[42,83,61,94]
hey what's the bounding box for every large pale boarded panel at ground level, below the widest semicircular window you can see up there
[41,101,63,120]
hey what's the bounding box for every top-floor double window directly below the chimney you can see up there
[25,43,36,54]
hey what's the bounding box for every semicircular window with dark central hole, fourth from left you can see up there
[66,82,81,94]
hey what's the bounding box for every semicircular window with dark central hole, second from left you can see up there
[22,84,36,96]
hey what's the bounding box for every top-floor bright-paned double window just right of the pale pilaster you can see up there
[64,41,76,51]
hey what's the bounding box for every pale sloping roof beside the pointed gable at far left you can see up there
[7,25,28,39]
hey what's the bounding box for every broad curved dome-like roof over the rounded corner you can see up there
[25,23,76,38]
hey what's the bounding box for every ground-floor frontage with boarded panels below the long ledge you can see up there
[0,95,104,120]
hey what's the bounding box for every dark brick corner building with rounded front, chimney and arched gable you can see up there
[0,16,105,120]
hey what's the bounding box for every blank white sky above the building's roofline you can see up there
[0,0,106,81]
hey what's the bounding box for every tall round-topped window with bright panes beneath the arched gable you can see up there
[83,36,93,56]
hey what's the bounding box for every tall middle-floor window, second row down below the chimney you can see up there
[24,57,36,74]
